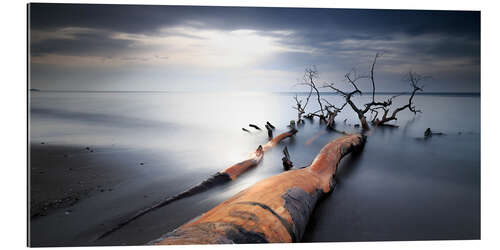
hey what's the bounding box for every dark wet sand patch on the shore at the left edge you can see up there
[30,145,133,219]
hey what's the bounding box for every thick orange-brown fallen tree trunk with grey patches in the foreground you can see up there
[150,134,365,245]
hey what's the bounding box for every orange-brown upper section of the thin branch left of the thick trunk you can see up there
[220,129,297,180]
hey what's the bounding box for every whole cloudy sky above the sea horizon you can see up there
[28,4,480,92]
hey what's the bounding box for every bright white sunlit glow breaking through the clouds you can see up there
[32,26,308,68]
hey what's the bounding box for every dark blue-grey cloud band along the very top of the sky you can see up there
[30,4,480,37]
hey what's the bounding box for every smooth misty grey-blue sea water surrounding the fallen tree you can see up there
[29,92,480,246]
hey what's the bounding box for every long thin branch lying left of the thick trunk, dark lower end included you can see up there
[97,129,297,240]
